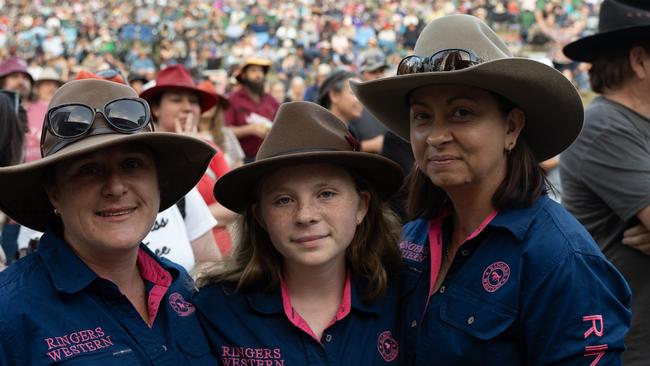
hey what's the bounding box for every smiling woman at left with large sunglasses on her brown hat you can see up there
[0,80,216,365]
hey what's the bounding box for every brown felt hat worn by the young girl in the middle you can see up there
[214,102,403,213]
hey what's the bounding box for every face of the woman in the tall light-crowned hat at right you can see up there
[410,85,525,192]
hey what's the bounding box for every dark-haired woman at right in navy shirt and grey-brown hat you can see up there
[352,15,630,365]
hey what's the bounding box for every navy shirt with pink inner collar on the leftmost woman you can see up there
[0,232,217,366]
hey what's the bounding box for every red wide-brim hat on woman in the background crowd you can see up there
[140,65,217,113]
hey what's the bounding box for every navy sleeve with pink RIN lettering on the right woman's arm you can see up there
[521,252,631,365]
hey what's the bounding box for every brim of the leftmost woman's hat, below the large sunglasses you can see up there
[0,132,215,231]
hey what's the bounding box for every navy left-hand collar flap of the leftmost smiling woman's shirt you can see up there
[36,231,97,294]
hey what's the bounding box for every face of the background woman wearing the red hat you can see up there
[151,89,201,132]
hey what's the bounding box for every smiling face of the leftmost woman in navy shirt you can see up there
[47,145,160,258]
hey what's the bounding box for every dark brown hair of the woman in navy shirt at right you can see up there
[404,92,550,220]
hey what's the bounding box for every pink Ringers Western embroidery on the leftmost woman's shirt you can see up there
[43,327,113,361]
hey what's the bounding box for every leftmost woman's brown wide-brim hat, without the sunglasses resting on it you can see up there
[0,79,215,231]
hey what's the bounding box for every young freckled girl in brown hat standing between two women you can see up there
[195,102,402,365]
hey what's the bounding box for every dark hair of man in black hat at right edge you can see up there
[589,40,650,94]
